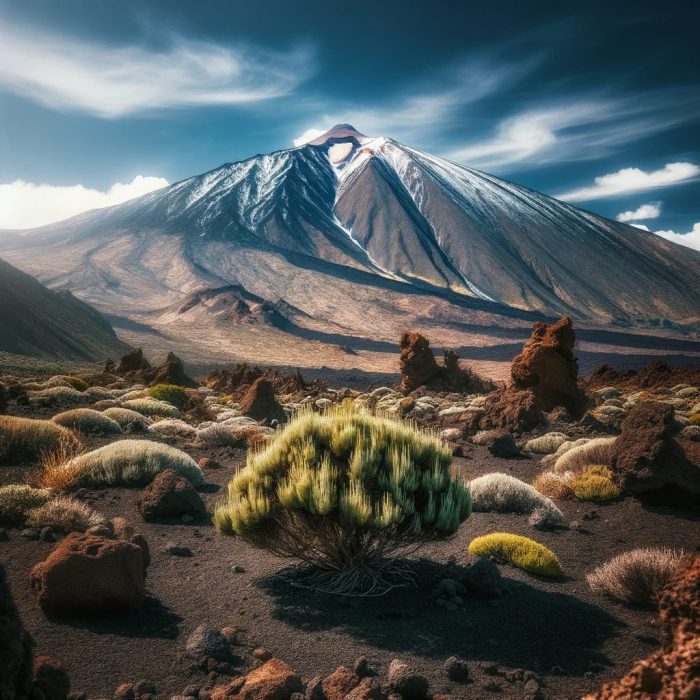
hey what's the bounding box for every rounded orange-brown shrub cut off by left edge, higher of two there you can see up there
[0,416,78,463]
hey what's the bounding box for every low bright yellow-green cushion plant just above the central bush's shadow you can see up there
[469,532,564,577]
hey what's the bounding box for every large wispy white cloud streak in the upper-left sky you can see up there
[0,22,312,118]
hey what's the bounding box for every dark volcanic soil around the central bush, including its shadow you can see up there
[0,438,700,699]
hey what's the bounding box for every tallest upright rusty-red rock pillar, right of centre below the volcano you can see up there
[510,316,585,416]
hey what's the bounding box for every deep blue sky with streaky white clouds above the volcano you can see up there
[0,0,700,246]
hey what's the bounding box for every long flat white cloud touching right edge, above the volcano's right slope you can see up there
[556,163,700,202]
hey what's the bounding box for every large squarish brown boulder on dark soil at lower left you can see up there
[30,533,147,615]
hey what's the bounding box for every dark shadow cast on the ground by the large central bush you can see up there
[257,560,621,675]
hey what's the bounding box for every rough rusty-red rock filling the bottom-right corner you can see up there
[583,555,700,700]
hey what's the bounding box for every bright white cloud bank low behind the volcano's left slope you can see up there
[0,175,168,229]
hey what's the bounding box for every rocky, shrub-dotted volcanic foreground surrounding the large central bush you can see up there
[0,318,700,700]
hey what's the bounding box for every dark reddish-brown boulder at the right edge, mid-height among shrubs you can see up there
[610,401,700,500]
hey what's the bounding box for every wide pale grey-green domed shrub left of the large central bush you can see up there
[41,440,204,489]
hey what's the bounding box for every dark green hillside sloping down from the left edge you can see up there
[0,260,128,362]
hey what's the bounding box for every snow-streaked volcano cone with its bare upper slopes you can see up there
[0,124,700,326]
